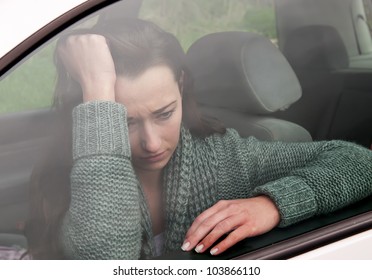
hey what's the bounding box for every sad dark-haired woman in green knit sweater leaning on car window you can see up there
[27,20,372,259]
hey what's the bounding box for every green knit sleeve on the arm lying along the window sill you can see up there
[211,131,372,226]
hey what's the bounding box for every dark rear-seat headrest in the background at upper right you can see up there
[283,25,349,71]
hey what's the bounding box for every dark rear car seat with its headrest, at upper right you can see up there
[276,25,349,140]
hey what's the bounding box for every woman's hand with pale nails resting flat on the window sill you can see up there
[182,196,280,255]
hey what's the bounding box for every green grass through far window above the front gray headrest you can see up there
[140,0,276,49]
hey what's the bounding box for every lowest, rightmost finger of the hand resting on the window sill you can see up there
[210,225,251,255]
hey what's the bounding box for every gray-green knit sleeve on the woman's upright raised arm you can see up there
[61,101,141,259]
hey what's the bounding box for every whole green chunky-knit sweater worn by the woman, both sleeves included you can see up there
[61,101,372,259]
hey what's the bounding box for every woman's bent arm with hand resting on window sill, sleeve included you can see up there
[183,131,372,254]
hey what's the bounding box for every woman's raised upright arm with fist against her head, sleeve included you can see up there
[58,35,141,259]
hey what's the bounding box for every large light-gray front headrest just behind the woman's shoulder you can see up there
[187,32,301,114]
